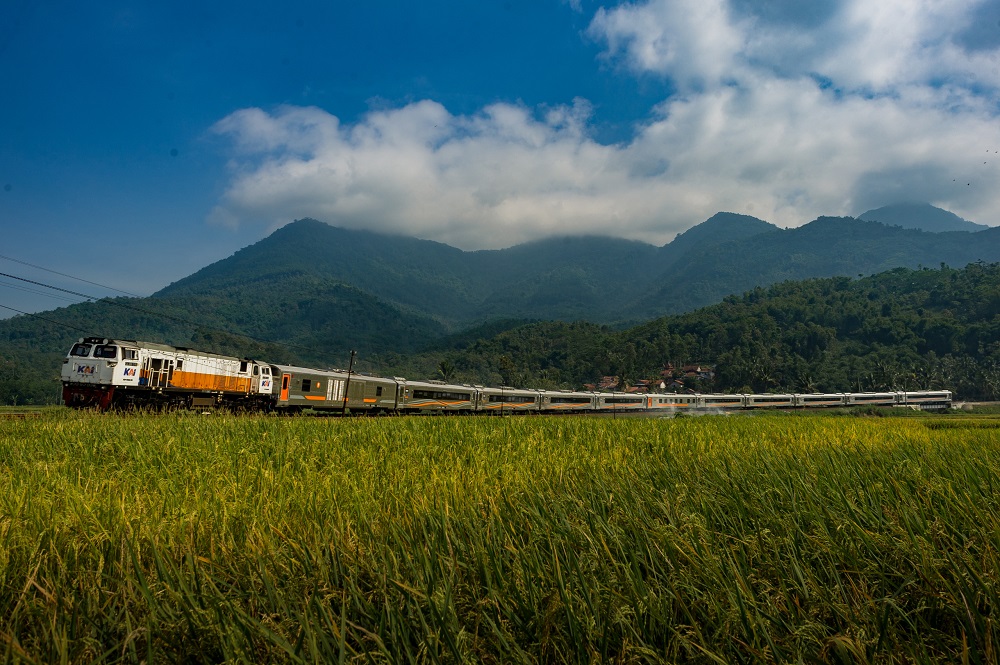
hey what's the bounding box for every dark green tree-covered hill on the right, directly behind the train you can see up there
[414,263,1000,399]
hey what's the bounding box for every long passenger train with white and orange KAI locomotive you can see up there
[61,337,952,415]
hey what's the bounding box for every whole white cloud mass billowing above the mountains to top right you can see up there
[210,0,1000,248]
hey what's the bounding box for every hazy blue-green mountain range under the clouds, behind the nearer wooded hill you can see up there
[9,213,1000,399]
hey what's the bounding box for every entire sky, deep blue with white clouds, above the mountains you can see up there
[0,0,1000,317]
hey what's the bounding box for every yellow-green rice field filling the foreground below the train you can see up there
[0,412,1000,663]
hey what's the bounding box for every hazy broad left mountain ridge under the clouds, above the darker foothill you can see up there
[153,219,658,331]
